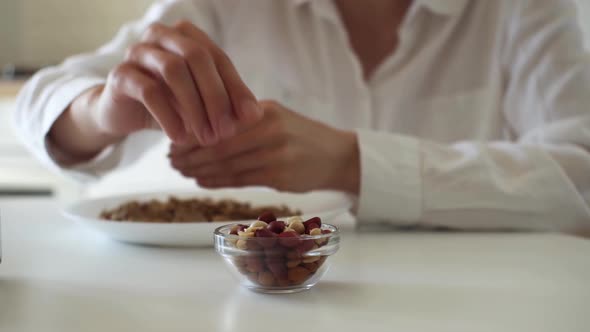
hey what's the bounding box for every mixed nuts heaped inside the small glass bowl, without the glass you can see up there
[230,213,331,287]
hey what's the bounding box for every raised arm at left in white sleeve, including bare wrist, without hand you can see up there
[14,0,218,178]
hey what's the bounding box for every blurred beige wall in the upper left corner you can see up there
[0,0,152,66]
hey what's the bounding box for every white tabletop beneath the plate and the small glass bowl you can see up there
[0,199,590,332]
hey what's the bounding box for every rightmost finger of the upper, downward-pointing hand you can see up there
[176,21,262,123]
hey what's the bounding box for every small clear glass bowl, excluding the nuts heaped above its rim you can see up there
[214,224,340,294]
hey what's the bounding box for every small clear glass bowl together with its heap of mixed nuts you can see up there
[214,213,340,294]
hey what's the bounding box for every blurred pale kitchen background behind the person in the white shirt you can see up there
[0,0,590,200]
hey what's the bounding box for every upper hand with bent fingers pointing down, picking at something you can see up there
[93,21,262,146]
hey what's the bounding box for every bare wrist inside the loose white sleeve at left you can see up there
[47,85,121,164]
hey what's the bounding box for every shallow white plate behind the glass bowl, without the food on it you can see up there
[63,189,351,247]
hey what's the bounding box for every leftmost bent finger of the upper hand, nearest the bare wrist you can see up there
[111,63,186,144]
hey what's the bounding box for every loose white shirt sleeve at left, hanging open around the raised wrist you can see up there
[14,0,218,180]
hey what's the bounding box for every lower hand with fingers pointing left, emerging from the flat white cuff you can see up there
[169,101,360,194]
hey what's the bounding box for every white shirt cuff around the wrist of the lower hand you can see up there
[357,130,422,225]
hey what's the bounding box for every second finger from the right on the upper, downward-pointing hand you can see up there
[144,25,236,145]
